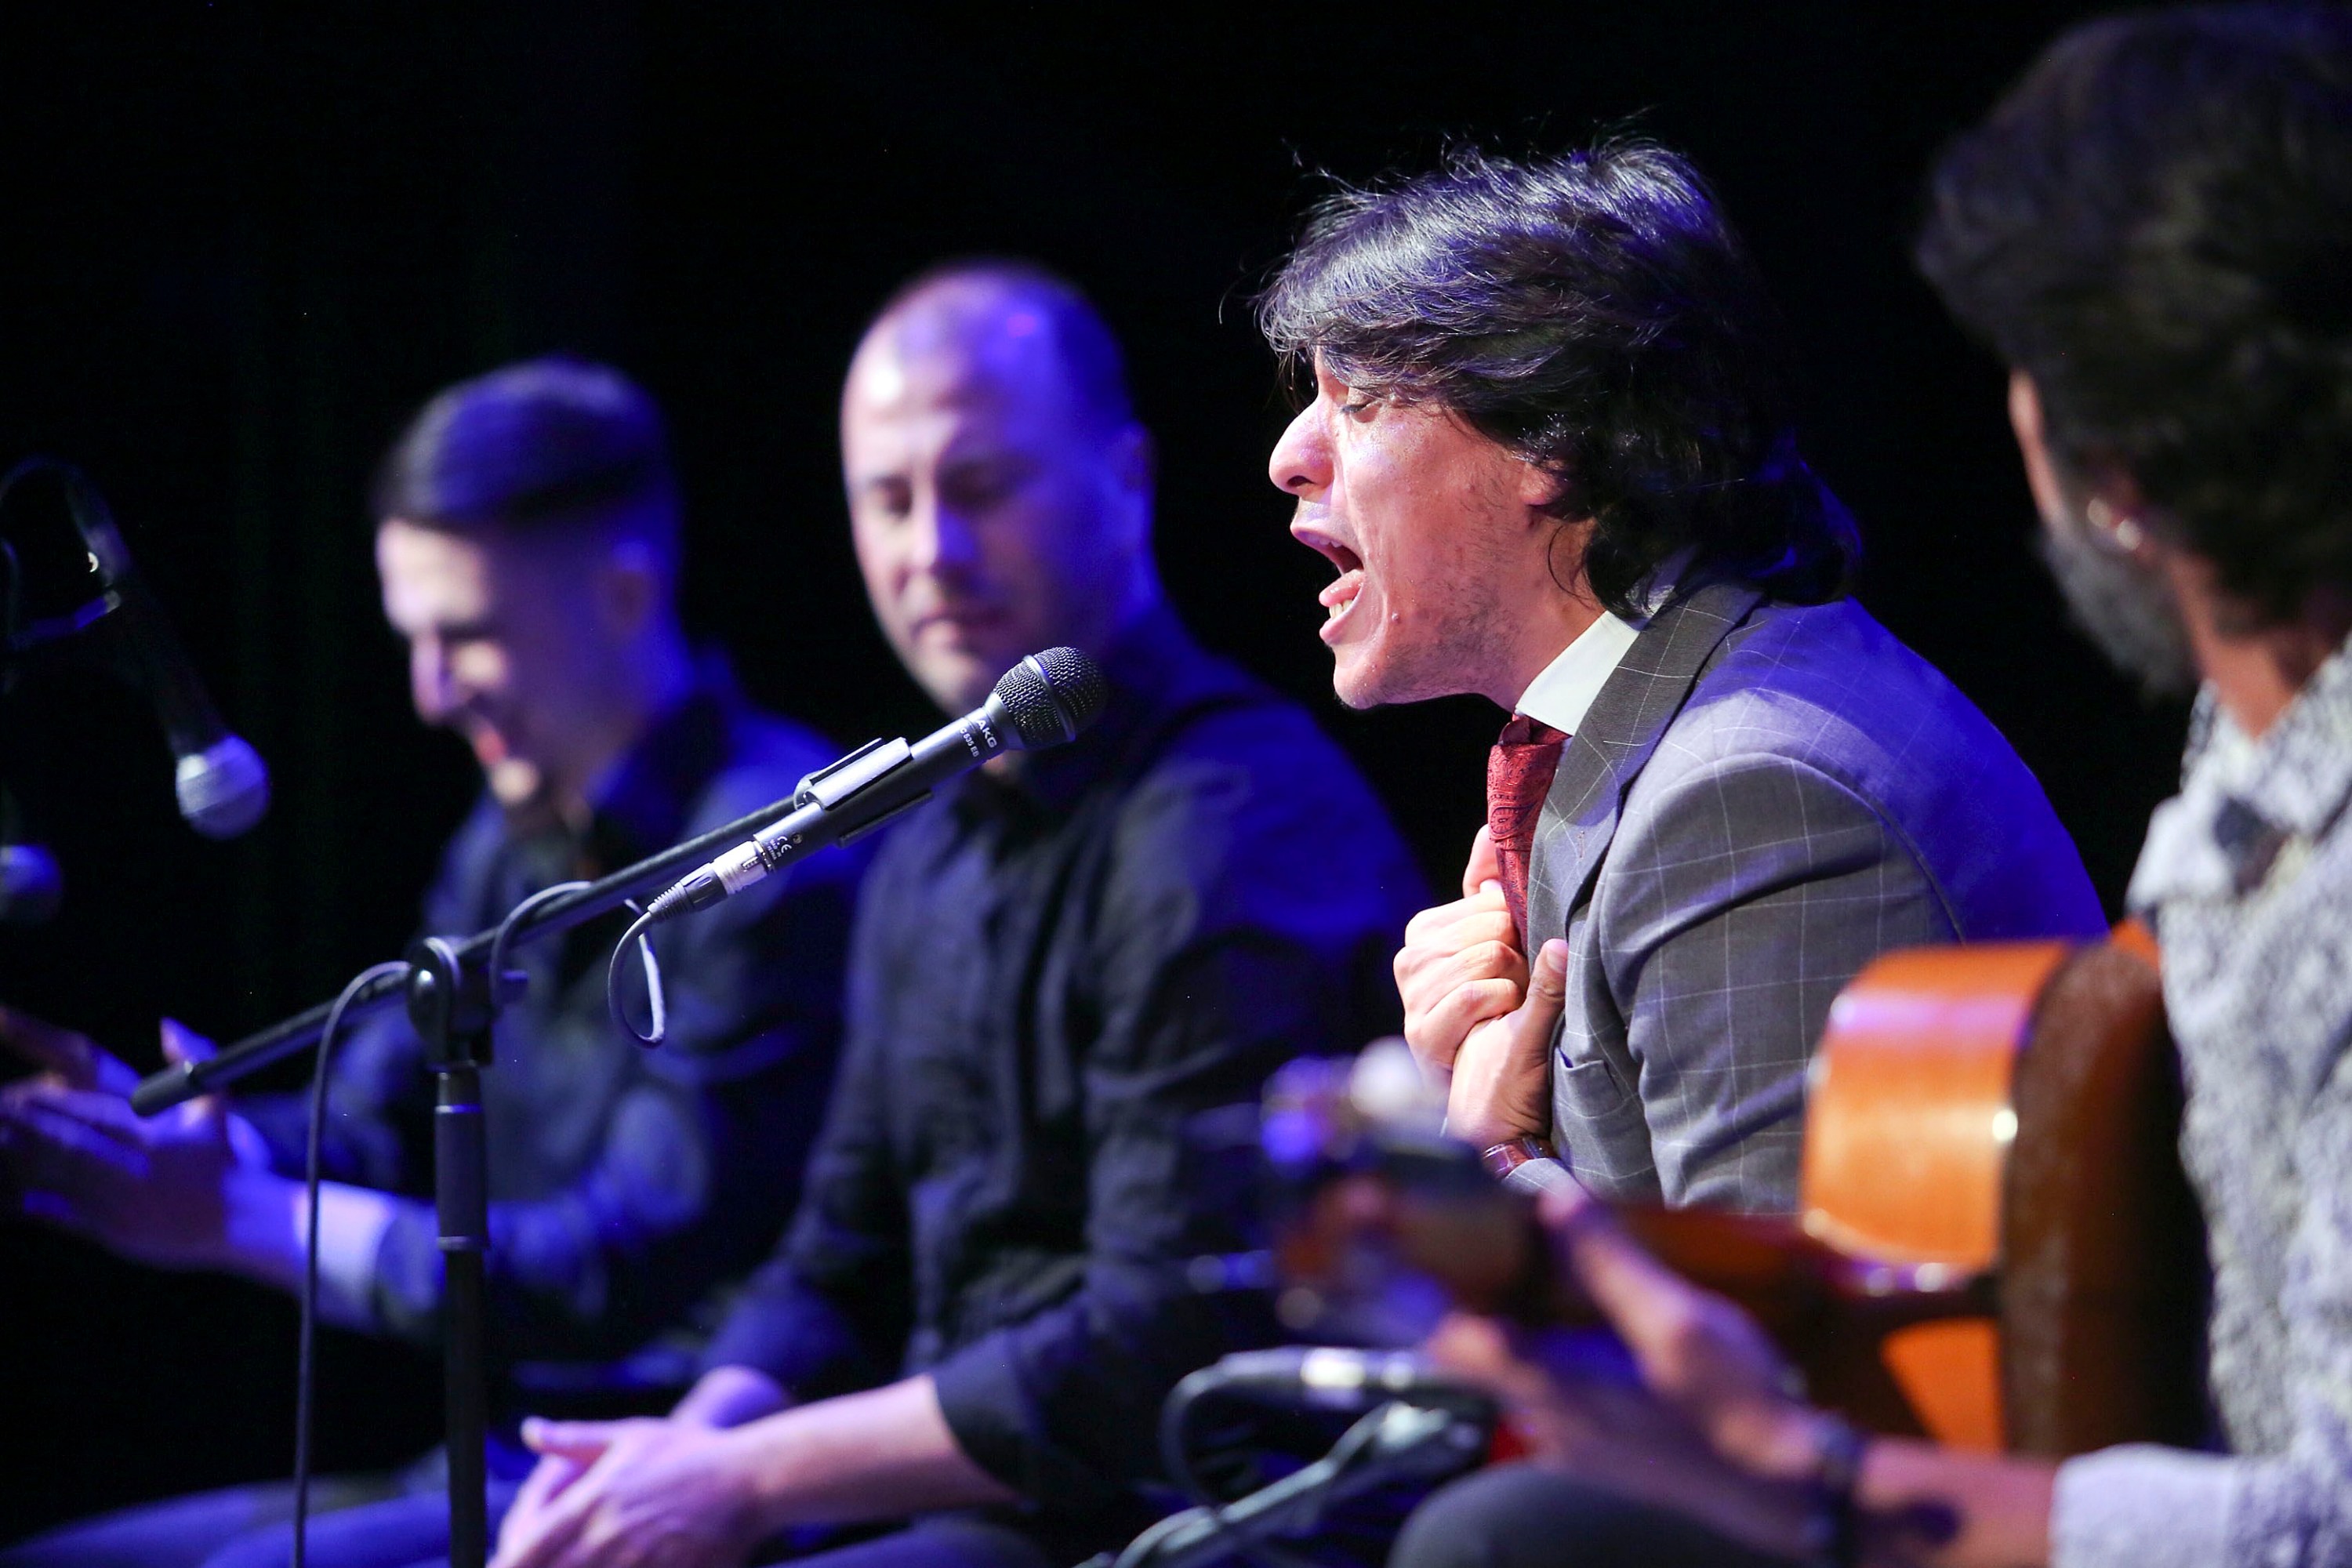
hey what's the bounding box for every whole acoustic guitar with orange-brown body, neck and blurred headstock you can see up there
[1265,928,2204,1455]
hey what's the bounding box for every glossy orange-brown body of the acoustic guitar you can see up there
[1802,926,2204,1455]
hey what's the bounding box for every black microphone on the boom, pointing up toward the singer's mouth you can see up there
[644,649,1110,926]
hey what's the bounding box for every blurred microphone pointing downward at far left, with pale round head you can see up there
[64,468,270,839]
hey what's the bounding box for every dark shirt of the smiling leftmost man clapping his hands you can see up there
[240,661,863,1413]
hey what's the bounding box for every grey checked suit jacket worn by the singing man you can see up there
[1522,583,2103,1213]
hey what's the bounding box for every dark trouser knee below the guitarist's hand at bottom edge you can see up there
[1388,1465,1790,1568]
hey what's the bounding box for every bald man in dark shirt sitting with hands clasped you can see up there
[499,263,1418,1568]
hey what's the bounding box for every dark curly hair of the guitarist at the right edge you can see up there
[1919,5,2352,621]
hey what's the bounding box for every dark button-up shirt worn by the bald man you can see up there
[708,612,1423,1514]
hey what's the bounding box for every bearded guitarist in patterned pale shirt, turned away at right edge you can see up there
[1397,7,2352,1568]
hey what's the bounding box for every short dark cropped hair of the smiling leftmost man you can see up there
[369,355,680,557]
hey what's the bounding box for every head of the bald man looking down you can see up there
[842,263,1157,713]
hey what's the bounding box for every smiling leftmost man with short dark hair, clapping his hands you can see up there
[0,360,861,1568]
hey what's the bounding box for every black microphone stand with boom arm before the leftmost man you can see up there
[132,775,818,1568]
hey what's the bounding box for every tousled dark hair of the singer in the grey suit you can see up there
[1258,139,1860,614]
